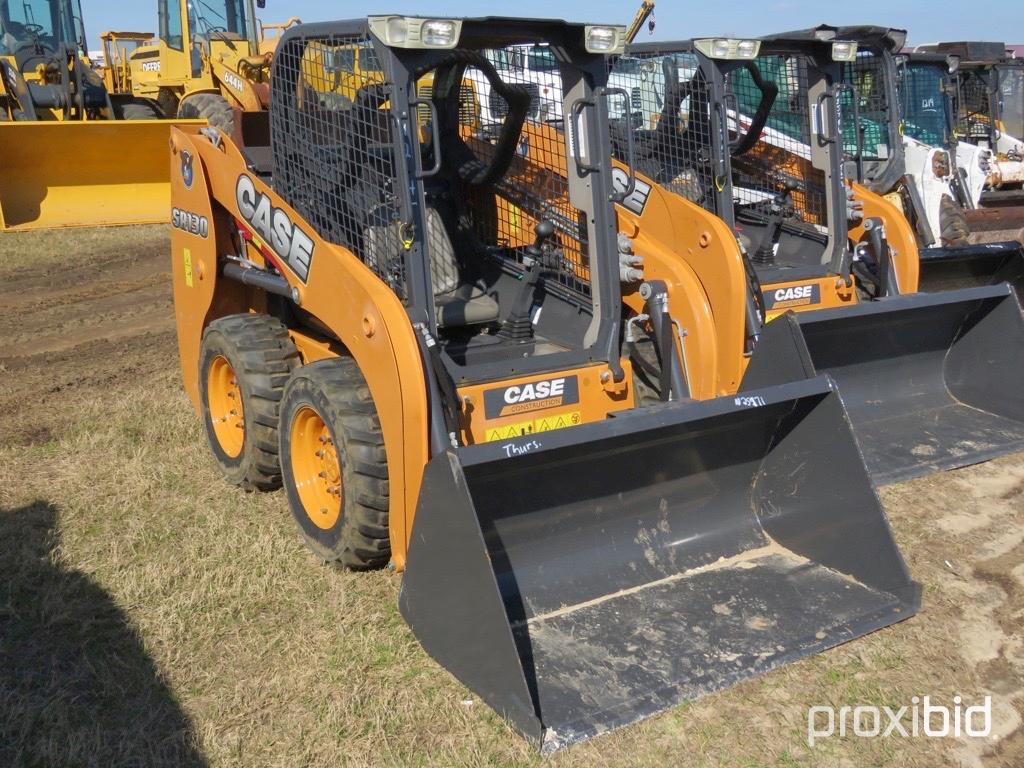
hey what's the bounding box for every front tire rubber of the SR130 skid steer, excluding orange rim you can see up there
[279,357,391,570]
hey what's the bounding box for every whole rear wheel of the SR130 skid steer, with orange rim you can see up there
[199,314,299,490]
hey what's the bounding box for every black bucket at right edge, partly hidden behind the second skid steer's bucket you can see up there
[918,241,1024,294]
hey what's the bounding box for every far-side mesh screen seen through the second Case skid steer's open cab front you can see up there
[726,54,827,227]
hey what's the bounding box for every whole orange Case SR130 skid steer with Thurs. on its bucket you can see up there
[171,16,920,753]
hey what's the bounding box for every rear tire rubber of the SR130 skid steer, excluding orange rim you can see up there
[199,314,300,490]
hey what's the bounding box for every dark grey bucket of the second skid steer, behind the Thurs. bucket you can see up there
[743,283,1024,484]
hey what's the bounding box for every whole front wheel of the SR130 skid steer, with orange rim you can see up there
[280,357,391,570]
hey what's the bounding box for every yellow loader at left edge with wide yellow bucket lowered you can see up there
[0,0,197,231]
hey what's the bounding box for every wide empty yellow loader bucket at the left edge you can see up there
[0,120,205,231]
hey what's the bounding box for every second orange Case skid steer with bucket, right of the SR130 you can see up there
[610,31,1024,483]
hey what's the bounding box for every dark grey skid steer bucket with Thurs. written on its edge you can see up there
[399,377,920,753]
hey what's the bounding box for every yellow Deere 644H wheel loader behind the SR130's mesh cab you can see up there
[121,0,299,135]
